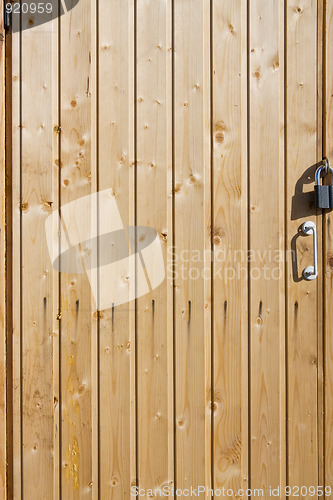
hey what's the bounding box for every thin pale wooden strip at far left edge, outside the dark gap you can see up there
[0,2,7,499]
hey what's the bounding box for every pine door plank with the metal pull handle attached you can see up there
[286,0,321,486]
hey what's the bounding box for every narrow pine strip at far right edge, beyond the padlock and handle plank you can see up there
[324,1,333,487]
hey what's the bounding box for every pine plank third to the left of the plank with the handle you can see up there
[174,0,211,498]
